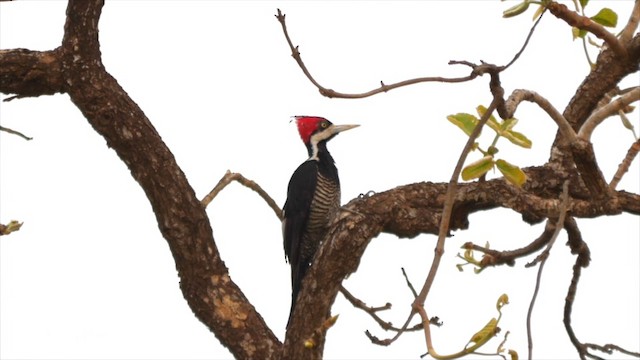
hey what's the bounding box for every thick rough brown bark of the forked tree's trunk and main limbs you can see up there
[0,0,640,359]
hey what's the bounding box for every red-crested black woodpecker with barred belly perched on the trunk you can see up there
[282,116,359,327]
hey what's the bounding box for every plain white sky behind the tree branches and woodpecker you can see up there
[0,1,640,359]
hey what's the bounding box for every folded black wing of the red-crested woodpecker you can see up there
[282,160,318,269]
